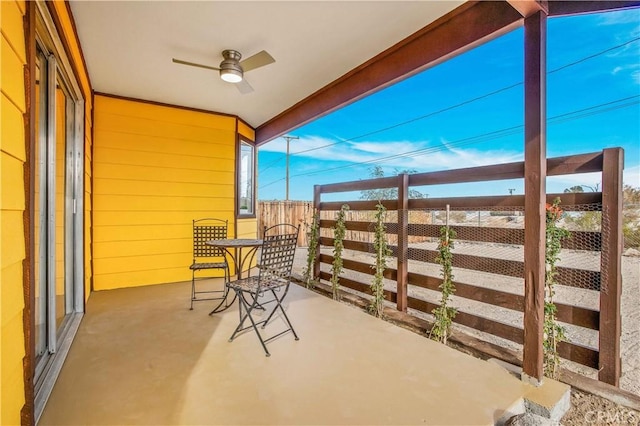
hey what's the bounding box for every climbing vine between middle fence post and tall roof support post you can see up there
[429,216,458,345]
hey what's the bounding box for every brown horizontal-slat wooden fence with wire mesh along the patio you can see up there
[312,149,623,386]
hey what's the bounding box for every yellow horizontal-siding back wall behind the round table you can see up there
[93,95,242,290]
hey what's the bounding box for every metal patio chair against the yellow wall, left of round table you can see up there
[189,218,230,310]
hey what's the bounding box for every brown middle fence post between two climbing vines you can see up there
[396,173,409,312]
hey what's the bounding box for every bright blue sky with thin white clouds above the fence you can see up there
[258,9,640,200]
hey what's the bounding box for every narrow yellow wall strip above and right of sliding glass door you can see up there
[54,0,93,300]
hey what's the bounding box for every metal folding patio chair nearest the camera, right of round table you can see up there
[227,224,300,356]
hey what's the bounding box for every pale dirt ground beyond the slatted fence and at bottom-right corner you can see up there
[294,243,640,425]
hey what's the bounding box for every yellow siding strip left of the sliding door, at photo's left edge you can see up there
[0,1,27,424]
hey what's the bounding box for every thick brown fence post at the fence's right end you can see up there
[598,148,624,386]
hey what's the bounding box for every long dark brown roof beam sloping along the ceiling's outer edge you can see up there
[256,1,521,145]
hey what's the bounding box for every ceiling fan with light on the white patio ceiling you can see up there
[173,49,276,94]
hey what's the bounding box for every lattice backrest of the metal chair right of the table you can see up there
[259,224,300,285]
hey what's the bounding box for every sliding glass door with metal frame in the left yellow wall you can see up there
[32,30,84,420]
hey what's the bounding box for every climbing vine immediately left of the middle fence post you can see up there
[369,202,391,318]
